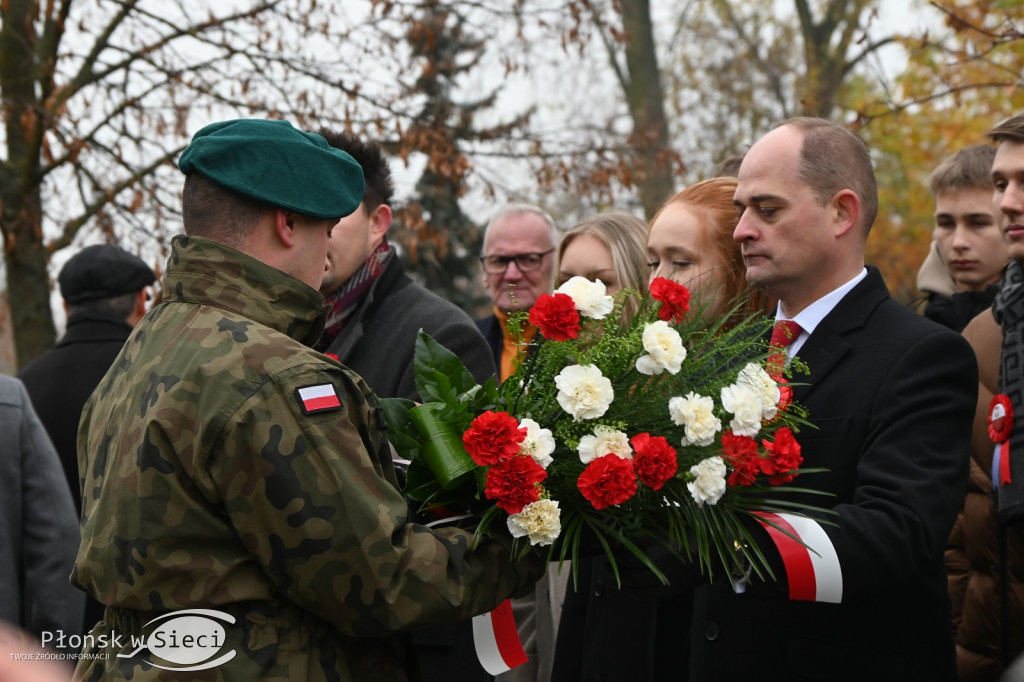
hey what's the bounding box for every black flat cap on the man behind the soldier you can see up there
[57,244,157,303]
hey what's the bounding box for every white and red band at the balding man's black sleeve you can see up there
[757,512,843,604]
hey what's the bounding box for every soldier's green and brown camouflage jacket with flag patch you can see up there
[72,237,538,682]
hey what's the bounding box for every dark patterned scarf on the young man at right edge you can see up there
[992,260,1024,522]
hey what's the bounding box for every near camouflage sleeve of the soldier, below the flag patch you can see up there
[201,367,543,636]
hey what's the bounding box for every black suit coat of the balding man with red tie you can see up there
[689,267,978,682]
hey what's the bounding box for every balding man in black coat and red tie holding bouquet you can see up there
[689,119,978,682]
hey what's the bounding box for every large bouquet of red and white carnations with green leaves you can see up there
[384,278,827,582]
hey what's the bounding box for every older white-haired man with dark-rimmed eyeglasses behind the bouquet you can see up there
[476,204,559,379]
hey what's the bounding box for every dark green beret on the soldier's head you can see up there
[178,119,365,219]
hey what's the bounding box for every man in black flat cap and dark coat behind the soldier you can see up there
[17,244,157,634]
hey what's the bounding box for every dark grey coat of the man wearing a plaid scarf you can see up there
[326,257,495,400]
